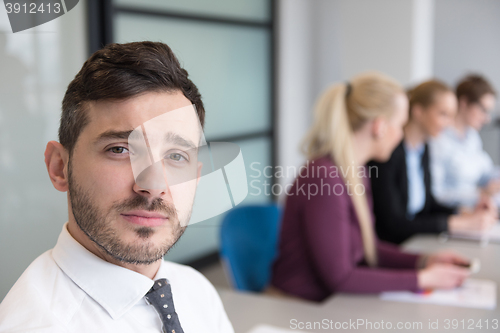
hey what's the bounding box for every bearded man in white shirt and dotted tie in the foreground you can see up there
[0,42,233,333]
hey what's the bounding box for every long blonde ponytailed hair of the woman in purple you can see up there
[303,73,403,266]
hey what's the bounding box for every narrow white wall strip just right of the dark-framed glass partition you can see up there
[276,0,315,197]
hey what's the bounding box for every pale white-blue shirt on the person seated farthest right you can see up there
[429,127,494,207]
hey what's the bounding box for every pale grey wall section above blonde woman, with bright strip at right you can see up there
[311,0,434,93]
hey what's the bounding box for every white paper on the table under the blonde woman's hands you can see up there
[380,279,497,310]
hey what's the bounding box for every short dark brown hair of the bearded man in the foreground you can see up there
[59,41,205,155]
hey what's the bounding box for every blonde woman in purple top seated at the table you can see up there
[269,73,468,301]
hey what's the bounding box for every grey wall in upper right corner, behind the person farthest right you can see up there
[434,0,500,164]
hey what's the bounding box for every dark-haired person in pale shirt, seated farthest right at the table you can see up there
[429,75,500,207]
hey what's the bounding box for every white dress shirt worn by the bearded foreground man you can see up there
[0,224,234,333]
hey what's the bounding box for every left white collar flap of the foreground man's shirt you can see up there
[52,223,155,319]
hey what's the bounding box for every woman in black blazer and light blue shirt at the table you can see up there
[369,80,495,244]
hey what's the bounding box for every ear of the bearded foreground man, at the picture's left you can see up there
[45,141,69,192]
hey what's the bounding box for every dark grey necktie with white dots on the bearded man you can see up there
[145,279,184,333]
